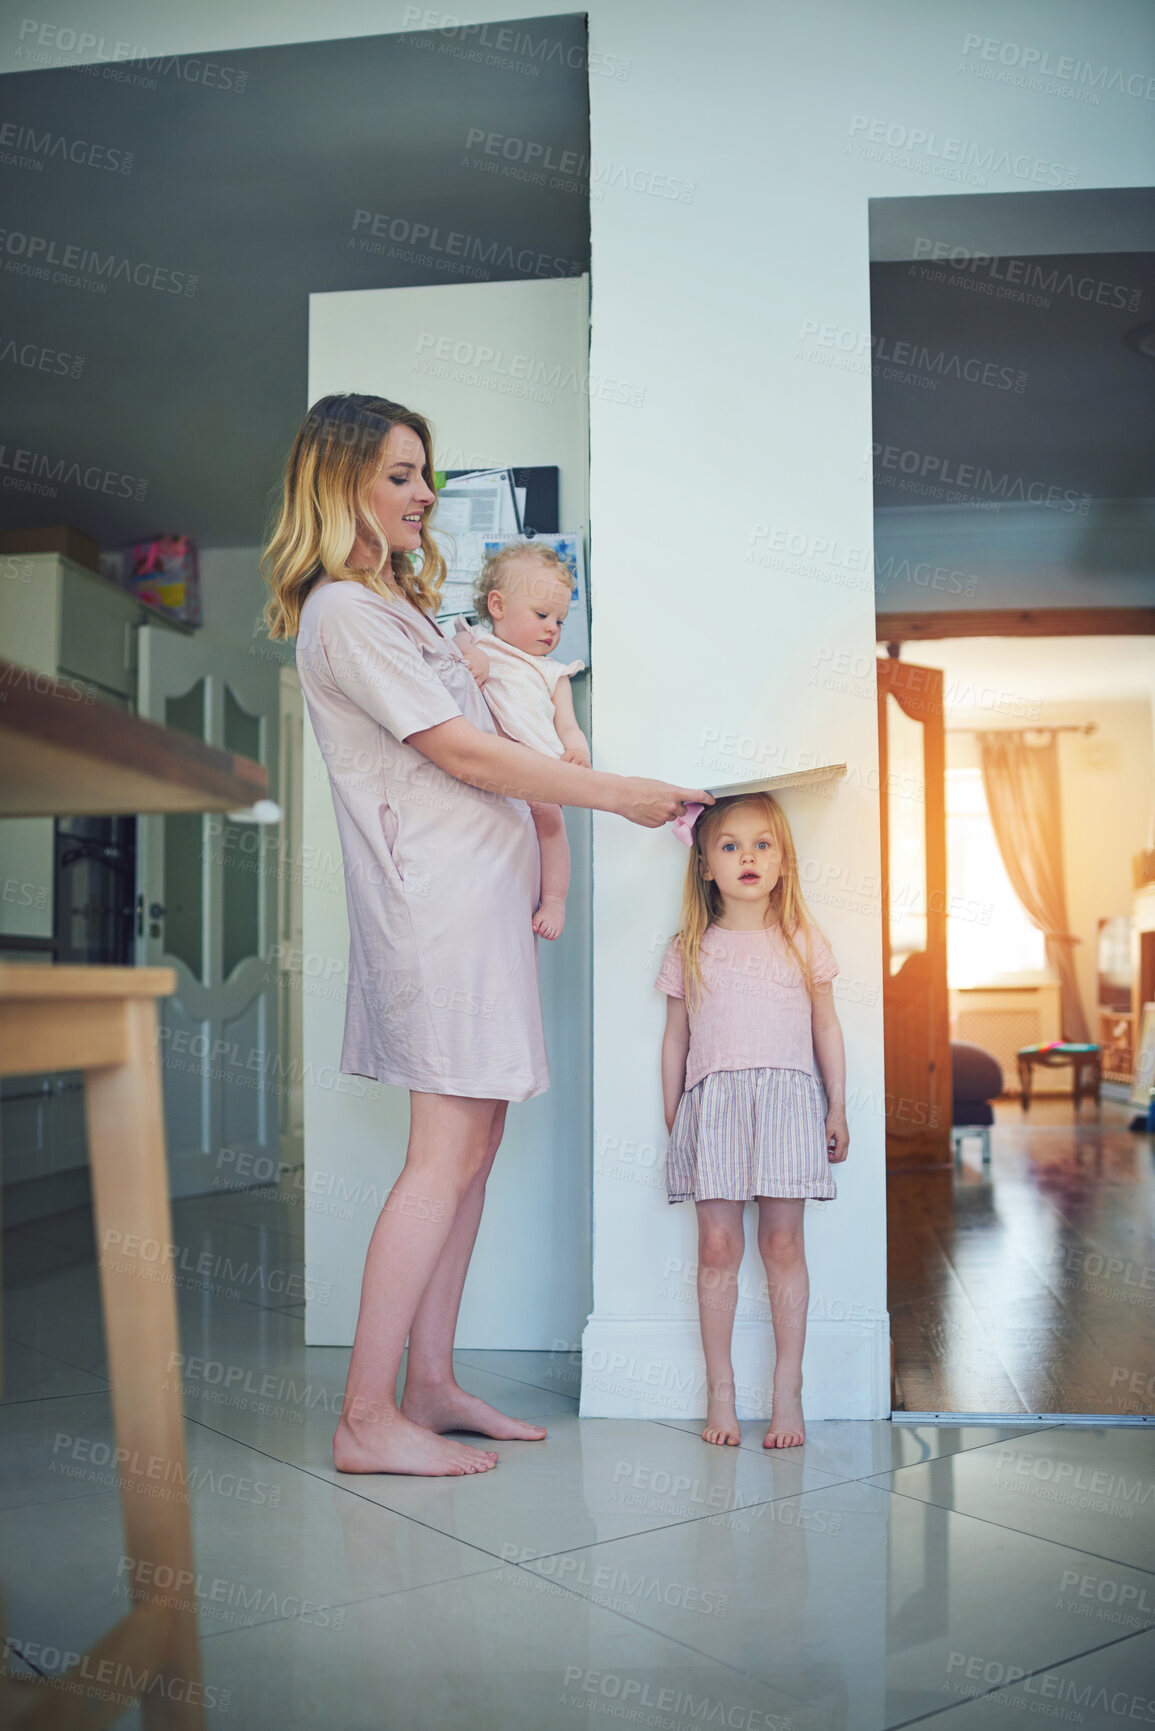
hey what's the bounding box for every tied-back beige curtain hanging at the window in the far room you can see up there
[978,730,1091,1040]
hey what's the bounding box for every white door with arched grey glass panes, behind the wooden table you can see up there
[137,625,287,1196]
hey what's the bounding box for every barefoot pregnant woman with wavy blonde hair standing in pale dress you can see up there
[261,395,710,1477]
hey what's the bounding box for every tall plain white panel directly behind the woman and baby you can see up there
[301,277,590,1348]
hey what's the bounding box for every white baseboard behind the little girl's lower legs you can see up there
[580,1314,890,1419]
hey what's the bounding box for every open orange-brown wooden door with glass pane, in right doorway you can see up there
[878,660,951,1168]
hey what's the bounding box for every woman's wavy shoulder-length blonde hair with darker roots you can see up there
[261,395,445,637]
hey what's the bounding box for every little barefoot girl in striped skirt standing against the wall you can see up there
[655,793,850,1449]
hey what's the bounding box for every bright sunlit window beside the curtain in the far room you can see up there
[947,769,1048,987]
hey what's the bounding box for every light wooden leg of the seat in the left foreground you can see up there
[85,999,204,1731]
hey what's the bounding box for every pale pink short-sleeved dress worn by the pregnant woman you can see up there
[296,578,549,1101]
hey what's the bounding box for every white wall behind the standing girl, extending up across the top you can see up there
[31,0,1155,1416]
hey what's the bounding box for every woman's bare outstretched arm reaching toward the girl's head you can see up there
[405,715,713,829]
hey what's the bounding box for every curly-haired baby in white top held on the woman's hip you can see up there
[457,542,590,938]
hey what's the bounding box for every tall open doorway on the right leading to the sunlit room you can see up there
[871,179,1155,1423]
